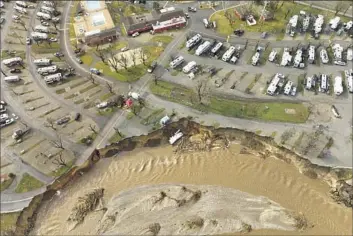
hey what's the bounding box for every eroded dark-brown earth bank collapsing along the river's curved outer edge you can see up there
[9,118,353,235]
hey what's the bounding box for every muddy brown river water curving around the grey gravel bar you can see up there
[31,144,352,235]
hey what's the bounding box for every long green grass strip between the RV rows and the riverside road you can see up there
[150,81,309,123]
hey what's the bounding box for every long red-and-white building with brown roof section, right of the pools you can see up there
[125,7,187,35]
